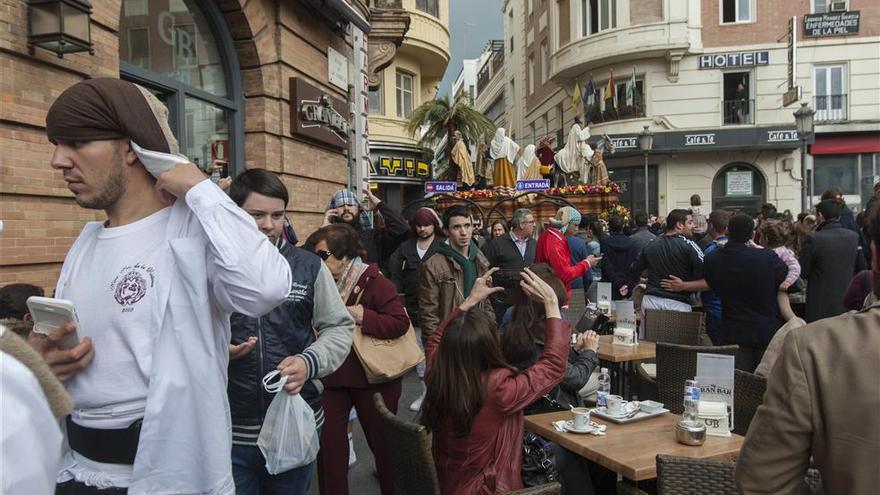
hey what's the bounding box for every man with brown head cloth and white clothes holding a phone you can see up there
[31,79,291,494]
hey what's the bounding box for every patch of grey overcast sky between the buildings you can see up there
[437,0,504,96]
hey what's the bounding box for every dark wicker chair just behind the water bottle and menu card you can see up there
[657,342,739,414]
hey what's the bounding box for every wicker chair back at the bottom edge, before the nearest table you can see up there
[657,454,740,495]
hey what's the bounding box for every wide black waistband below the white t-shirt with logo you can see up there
[67,416,143,464]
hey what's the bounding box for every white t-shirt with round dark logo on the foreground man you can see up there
[64,208,173,429]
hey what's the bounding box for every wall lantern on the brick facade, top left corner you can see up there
[27,0,95,58]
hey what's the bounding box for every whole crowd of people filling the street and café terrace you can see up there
[0,79,880,495]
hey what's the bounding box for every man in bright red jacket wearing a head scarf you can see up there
[535,206,601,306]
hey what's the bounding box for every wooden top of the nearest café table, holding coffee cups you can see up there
[525,411,743,481]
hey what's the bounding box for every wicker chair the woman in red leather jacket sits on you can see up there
[373,393,562,495]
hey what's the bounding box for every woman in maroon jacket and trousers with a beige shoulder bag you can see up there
[305,223,409,495]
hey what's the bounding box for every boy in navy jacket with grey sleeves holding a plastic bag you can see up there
[227,169,354,495]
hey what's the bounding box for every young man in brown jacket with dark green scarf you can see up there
[419,205,495,341]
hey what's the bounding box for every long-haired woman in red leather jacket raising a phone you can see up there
[421,268,571,495]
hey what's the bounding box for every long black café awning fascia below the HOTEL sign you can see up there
[590,127,800,156]
